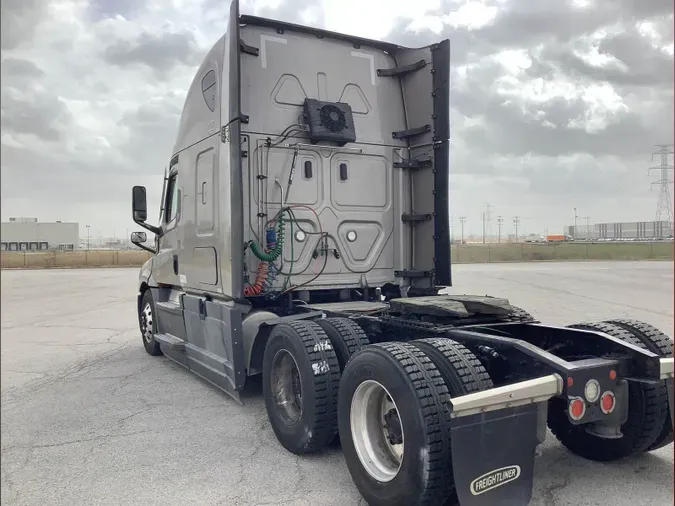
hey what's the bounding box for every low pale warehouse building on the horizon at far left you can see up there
[0,218,80,251]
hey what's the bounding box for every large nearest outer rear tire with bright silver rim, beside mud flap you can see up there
[338,342,453,506]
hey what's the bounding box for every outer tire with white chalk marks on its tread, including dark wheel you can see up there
[262,320,340,455]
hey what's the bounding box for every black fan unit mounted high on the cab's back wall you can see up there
[304,98,356,146]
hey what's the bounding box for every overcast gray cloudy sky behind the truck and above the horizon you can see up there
[1,0,673,241]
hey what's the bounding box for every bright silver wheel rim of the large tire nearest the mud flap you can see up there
[349,380,405,483]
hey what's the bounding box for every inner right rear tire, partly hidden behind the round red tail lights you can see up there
[548,323,666,462]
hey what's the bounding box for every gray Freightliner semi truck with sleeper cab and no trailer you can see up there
[132,0,673,506]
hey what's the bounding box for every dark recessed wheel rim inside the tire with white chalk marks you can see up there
[270,350,302,425]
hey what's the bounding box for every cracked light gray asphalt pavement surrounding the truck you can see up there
[0,262,673,506]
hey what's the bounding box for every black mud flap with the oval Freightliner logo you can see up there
[452,403,539,506]
